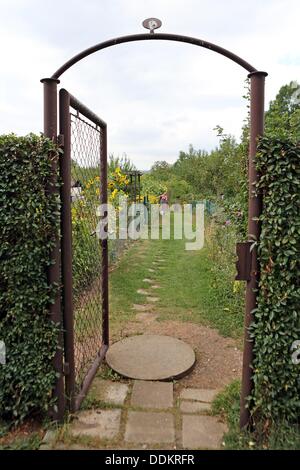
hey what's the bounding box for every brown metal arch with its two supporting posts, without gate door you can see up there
[41,33,267,427]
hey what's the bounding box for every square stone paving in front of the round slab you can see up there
[48,378,227,450]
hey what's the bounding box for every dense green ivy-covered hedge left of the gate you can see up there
[0,134,59,422]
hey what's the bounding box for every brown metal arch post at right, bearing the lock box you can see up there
[240,72,268,428]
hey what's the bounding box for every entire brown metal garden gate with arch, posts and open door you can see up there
[41,18,267,427]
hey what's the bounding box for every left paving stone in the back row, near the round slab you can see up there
[90,377,129,405]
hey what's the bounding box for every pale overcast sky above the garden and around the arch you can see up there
[0,0,300,170]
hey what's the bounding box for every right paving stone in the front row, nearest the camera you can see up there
[182,415,227,450]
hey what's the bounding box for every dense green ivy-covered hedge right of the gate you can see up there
[251,137,300,427]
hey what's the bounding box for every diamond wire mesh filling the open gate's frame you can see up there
[71,109,102,393]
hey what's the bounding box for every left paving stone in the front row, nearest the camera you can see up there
[70,409,121,439]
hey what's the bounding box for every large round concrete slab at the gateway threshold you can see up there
[106,335,196,380]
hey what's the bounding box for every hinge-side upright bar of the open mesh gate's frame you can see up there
[59,90,75,412]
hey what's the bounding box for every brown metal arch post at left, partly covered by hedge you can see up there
[41,78,65,421]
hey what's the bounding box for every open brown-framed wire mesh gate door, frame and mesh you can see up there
[59,89,109,411]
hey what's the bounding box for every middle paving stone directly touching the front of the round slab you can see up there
[131,380,173,409]
